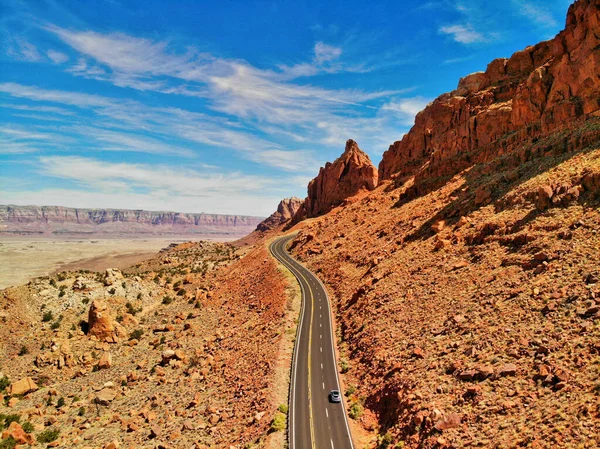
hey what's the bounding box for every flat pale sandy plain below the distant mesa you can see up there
[0,236,237,289]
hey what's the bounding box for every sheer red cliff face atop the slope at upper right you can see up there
[379,0,600,182]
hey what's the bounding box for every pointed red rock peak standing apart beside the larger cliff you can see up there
[299,140,377,217]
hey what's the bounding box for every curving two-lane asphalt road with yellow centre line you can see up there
[271,236,354,449]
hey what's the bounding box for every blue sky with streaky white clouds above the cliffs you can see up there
[0,0,571,216]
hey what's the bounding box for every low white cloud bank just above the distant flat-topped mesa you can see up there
[3,156,296,216]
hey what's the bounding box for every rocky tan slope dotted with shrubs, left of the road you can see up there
[0,238,298,449]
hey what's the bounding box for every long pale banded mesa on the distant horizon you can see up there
[0,206,262,235]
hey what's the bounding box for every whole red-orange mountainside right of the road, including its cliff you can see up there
[276,0,600,448]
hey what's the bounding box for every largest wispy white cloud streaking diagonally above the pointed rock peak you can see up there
[43,26,408,152]
